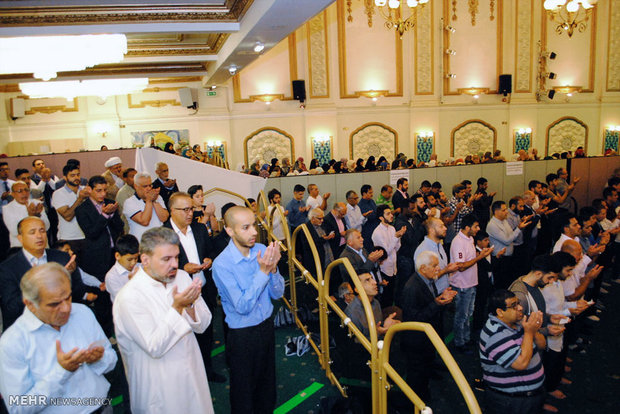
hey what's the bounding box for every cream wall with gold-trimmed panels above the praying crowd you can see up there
[0,0,620,167]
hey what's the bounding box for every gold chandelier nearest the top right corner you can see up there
[543,0,598,37]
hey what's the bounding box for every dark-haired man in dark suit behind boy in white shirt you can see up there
[75,175,123,282]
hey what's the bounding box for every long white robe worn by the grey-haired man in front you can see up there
[113,269,213,414]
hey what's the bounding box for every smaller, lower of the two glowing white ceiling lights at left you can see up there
[19,78,149,100]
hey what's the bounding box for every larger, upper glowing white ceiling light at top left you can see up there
[0,34,127,80]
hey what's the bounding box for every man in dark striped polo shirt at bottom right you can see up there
[480,290,545,414]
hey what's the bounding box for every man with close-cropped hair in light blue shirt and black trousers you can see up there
[213,206,284,414]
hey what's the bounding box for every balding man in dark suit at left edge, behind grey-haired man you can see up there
[0,216,89,330]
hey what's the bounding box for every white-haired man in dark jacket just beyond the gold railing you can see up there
[401,251,456,402]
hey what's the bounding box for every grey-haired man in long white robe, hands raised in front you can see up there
[113,227,213,414]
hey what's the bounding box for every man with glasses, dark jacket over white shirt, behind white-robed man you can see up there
[164,192,226,382]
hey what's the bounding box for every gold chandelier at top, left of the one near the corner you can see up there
[354,0,428,38]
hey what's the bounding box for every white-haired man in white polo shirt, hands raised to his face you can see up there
[123,173,170,240]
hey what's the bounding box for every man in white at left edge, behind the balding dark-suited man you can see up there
[2,181,50,247]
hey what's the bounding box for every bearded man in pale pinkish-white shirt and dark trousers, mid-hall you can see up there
[372,204,407,306]
